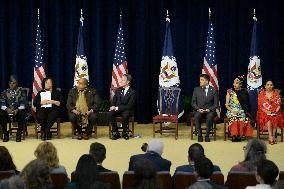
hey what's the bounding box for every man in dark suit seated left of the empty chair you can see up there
[109,74,135,140]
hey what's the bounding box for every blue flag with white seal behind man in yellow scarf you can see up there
[74,10,89,86]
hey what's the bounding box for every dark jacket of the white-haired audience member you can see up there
[128,151,172,171]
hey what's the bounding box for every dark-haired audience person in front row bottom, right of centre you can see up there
[194,157,227,189]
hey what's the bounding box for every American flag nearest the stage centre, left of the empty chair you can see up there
[111,15,128,97]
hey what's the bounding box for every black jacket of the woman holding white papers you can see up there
[33,90,64,111]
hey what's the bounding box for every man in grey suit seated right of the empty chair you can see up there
[191,74,218,142]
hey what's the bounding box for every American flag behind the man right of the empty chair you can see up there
[202,17,221,117]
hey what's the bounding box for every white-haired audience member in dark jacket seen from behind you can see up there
[128,139,172,171]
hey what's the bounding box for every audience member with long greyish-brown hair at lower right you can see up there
[230,139,267,172]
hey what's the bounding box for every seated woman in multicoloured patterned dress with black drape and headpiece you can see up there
[225,76,253,142]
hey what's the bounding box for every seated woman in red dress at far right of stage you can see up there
[257,80,283,145]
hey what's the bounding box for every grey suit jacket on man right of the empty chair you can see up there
[191,86,218,112]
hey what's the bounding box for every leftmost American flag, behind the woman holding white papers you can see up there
[32,10,46,117]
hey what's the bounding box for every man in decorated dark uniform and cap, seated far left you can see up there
[0,75,27,142]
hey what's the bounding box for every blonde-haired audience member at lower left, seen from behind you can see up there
[34,142,68,176]
